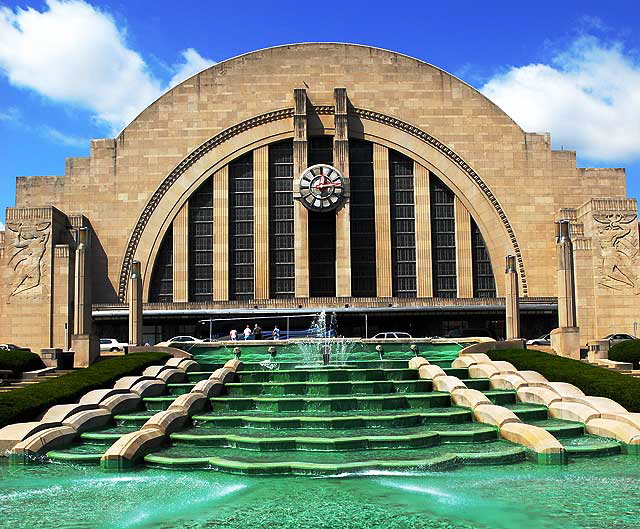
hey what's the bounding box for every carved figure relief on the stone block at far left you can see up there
[6,222,51,303]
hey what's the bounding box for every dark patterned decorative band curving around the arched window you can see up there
[118,105,529,302]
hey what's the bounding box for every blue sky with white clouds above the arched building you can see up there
[0,0,640,229]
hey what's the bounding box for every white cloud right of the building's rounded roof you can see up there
[480,35,640,162]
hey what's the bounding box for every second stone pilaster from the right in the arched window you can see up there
[413,162,433,298]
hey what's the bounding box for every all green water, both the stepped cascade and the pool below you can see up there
[6,342,640,529]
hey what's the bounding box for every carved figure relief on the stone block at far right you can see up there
[593,213,640,295]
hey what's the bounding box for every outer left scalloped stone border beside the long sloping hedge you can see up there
[0,358,197,464]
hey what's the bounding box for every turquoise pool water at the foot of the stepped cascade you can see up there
[0,456,640,529]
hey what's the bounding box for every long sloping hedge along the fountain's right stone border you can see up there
[487,349,640,412]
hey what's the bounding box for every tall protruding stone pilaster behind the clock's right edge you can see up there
[333,88,351,298]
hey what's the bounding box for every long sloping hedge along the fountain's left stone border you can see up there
[0,352,171,428]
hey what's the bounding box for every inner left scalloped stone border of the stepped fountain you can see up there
[100,358,242,471]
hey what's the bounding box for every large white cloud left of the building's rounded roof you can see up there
[0,0,211,132]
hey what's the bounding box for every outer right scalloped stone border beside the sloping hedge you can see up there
[458,354,640,455]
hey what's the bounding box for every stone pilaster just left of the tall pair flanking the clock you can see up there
[253,145,269,299]
